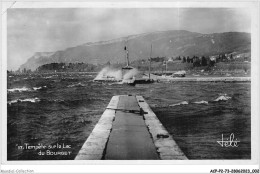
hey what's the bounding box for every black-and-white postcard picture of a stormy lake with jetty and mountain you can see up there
[1,2,259,173]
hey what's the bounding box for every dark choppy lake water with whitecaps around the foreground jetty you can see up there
[7,73,251,160]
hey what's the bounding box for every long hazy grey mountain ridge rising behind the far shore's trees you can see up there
[20,30,251,70]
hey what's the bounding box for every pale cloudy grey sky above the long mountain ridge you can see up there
[7,8,251,70]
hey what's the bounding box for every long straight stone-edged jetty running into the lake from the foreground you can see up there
[75,95,188,160]
